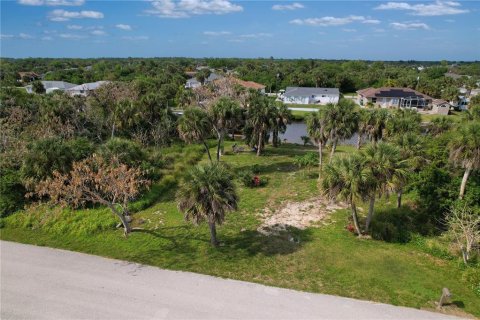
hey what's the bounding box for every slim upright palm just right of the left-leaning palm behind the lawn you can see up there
[209,97,242,161]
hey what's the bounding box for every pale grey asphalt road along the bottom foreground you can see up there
[0,241,464,319]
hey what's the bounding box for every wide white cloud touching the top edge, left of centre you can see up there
[145,0,243,18]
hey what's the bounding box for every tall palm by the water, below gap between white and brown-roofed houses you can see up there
[325,99,358,161]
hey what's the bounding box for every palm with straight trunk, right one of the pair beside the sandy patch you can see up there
[362,142,406,231]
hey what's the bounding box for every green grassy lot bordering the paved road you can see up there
[1,142,480,316]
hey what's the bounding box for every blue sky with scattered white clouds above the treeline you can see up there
[0,0,480,60]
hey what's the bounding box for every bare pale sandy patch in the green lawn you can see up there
[257,197,346,235]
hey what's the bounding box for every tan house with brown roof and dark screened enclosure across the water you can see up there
[357,88,433,108]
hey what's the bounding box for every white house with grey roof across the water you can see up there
[280,87,340,104]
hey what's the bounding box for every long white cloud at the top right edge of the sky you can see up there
[375,0,469,16]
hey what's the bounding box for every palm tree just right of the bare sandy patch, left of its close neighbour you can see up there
[321,154,370,235]
